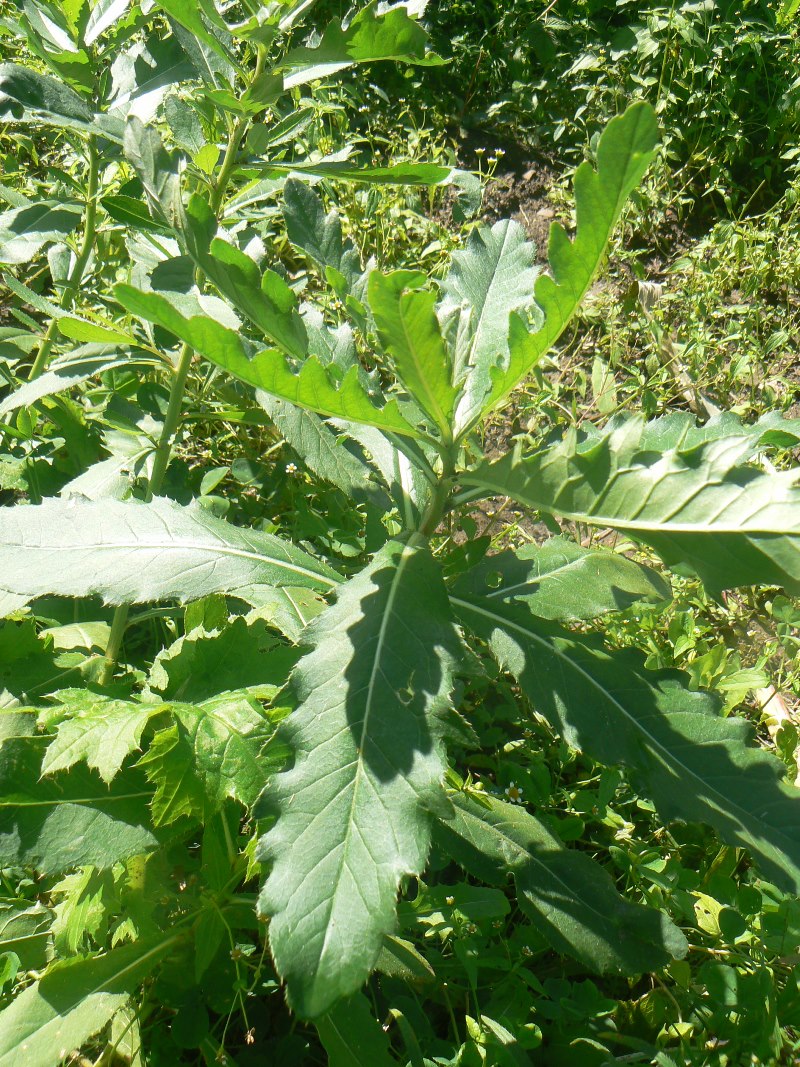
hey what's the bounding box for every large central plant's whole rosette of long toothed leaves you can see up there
[0,77,800,1063]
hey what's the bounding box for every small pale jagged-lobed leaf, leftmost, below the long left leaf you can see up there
[39,689,169,782]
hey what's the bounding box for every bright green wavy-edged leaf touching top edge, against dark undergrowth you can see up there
[279,0,444,89]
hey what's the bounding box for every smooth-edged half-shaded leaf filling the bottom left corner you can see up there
[0,934,179,1067]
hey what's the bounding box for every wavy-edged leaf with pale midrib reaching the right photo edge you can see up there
[462,418,800,592]
